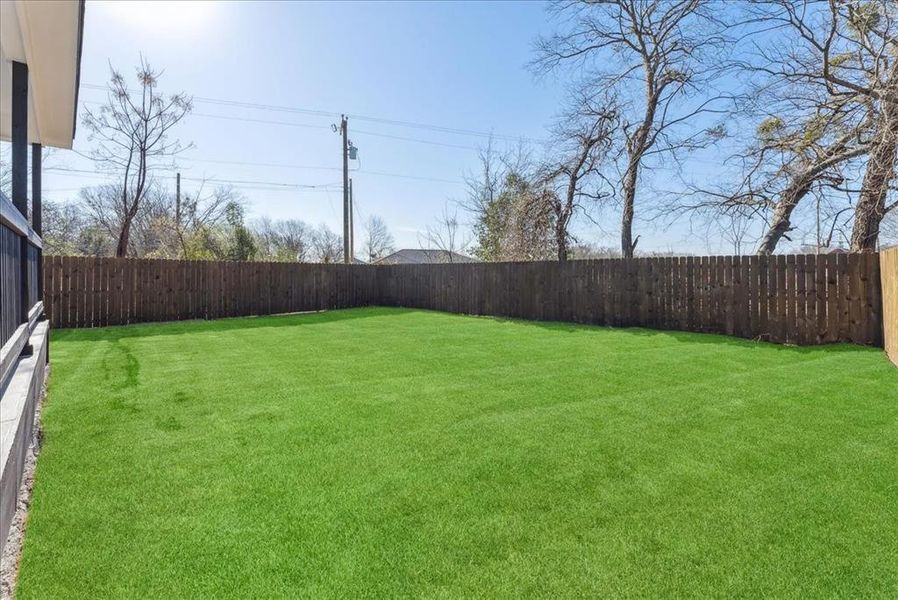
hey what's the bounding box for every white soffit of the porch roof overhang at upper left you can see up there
[0,0,84,148]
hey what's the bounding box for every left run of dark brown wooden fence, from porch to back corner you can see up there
[44,256,374,327]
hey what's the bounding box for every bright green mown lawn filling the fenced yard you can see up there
[17,309,898,600]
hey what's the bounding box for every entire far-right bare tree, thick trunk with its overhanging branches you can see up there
[751,0,898,251]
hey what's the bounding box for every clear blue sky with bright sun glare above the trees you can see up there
[36,2,748,252]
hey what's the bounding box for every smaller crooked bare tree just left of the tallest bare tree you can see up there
[541,107,616,261]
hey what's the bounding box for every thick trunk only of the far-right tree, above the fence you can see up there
[851,100,898,252]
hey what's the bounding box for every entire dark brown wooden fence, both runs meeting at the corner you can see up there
[44,254,891,346]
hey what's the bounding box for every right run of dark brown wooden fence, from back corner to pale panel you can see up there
[374,253,880,346]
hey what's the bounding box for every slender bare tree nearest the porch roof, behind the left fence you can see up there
[83,59,191,256]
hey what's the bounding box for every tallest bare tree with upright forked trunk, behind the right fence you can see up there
[533,0,726,257]
